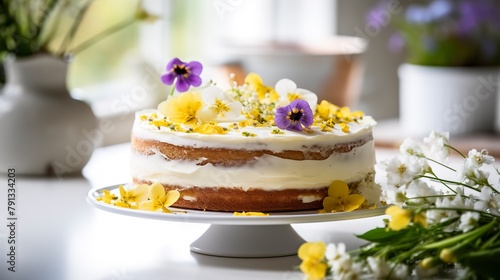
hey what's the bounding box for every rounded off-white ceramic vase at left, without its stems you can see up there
[0,54,97,177]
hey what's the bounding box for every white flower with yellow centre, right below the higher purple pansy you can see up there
[197,87,242,123]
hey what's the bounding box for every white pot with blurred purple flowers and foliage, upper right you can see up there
[368,0,500,135]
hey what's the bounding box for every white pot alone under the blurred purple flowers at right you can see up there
[398,64,500,136]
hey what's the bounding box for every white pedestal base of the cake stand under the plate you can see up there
[191,224,305,258]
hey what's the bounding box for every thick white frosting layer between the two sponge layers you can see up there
[131,141,375,190]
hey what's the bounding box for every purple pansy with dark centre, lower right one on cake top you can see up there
[274,99,314,131]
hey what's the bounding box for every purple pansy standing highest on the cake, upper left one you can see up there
[161,57,203,92]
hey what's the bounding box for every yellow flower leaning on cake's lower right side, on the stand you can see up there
[323,180,365,213]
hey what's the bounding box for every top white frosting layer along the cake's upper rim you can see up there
[132,110,376,152]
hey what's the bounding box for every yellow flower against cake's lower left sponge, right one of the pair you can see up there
[139,183,180,213]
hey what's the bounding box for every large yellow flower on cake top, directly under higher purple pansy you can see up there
[158,91,203,124]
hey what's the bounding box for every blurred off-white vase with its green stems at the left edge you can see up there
[0,0,156,177]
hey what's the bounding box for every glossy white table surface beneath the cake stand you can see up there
[0,144,402,280]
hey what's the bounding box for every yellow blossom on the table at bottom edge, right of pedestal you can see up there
[297,242,328,280]
